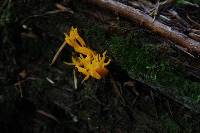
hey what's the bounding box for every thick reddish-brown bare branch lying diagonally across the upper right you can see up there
[83,0,200,55]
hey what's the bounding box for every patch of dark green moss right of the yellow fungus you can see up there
[107,33,200,100]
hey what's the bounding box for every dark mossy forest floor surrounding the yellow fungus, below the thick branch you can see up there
[0,0,200,133]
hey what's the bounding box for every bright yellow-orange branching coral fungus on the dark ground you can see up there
[52,27,111,80]
